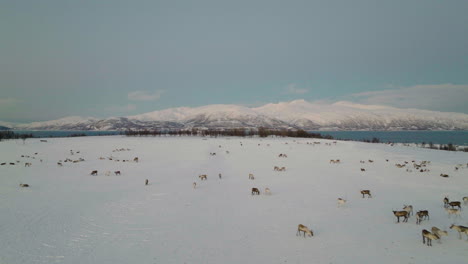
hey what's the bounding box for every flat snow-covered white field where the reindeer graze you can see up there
[0,136,468,264]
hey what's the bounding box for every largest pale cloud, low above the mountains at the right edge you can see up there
[350,84,468,113]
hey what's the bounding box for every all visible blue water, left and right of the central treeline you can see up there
[13,130,468,146]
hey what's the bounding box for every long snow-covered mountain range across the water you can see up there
[8,100,468,130]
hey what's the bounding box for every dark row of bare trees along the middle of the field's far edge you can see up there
[125,127,333,139]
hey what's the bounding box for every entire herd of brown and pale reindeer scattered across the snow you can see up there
[7,138,468,246]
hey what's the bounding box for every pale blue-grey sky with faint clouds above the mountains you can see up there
[0,0,468,122]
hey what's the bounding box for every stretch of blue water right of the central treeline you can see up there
[310,131,468,146]
